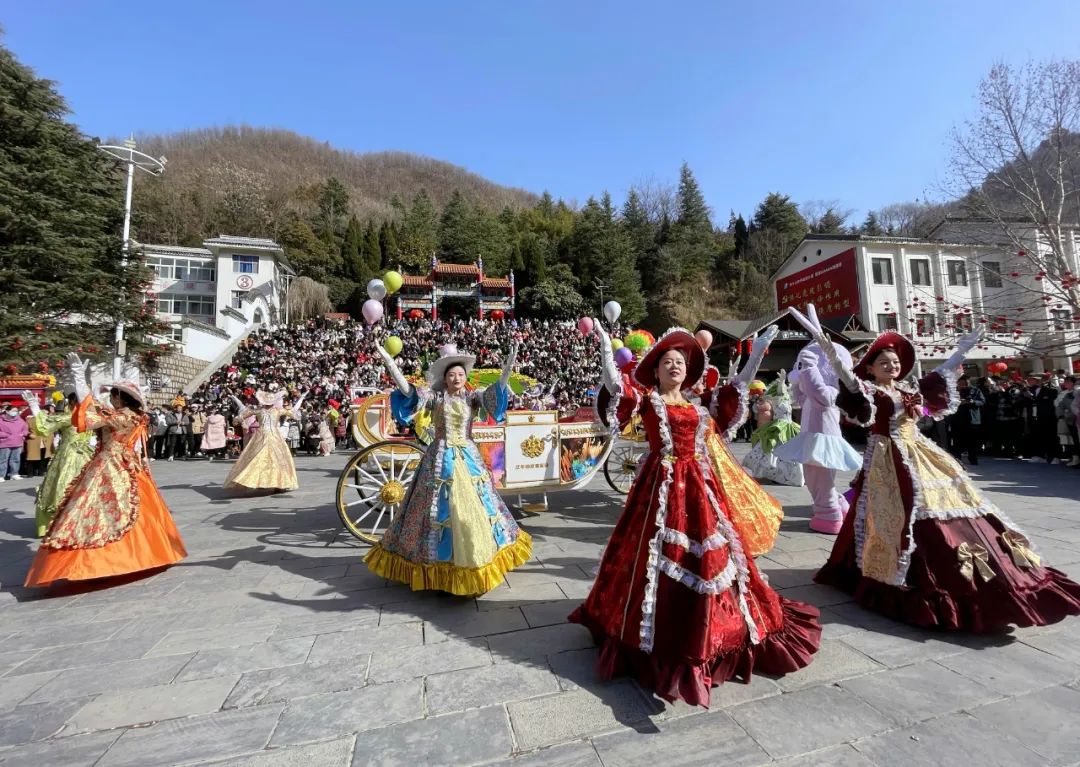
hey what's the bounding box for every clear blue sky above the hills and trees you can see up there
[0,0,1080,223]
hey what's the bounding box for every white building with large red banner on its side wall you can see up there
[771,220,1080,372]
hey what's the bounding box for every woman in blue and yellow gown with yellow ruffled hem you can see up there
[364,345,532,596]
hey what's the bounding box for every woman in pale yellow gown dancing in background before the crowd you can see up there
[225,391,307,493]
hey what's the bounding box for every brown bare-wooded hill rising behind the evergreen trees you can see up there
[135,125,539,245]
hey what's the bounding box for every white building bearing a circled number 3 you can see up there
[137,234,295,362]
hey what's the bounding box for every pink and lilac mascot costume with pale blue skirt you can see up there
[773,306,863,535]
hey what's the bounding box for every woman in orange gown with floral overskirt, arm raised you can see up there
[26,354,187,587]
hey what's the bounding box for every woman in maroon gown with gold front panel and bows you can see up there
[796,307,1080,632]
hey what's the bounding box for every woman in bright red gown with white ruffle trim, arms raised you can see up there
[570,322,821,708]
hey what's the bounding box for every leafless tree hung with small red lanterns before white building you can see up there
[945,60,1080,354]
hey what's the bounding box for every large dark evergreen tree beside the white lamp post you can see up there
[0,45,163,372]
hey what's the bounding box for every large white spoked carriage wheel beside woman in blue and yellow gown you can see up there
[337,441,423,543]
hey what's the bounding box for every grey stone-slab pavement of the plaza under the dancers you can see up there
[0,445,1080,767]
